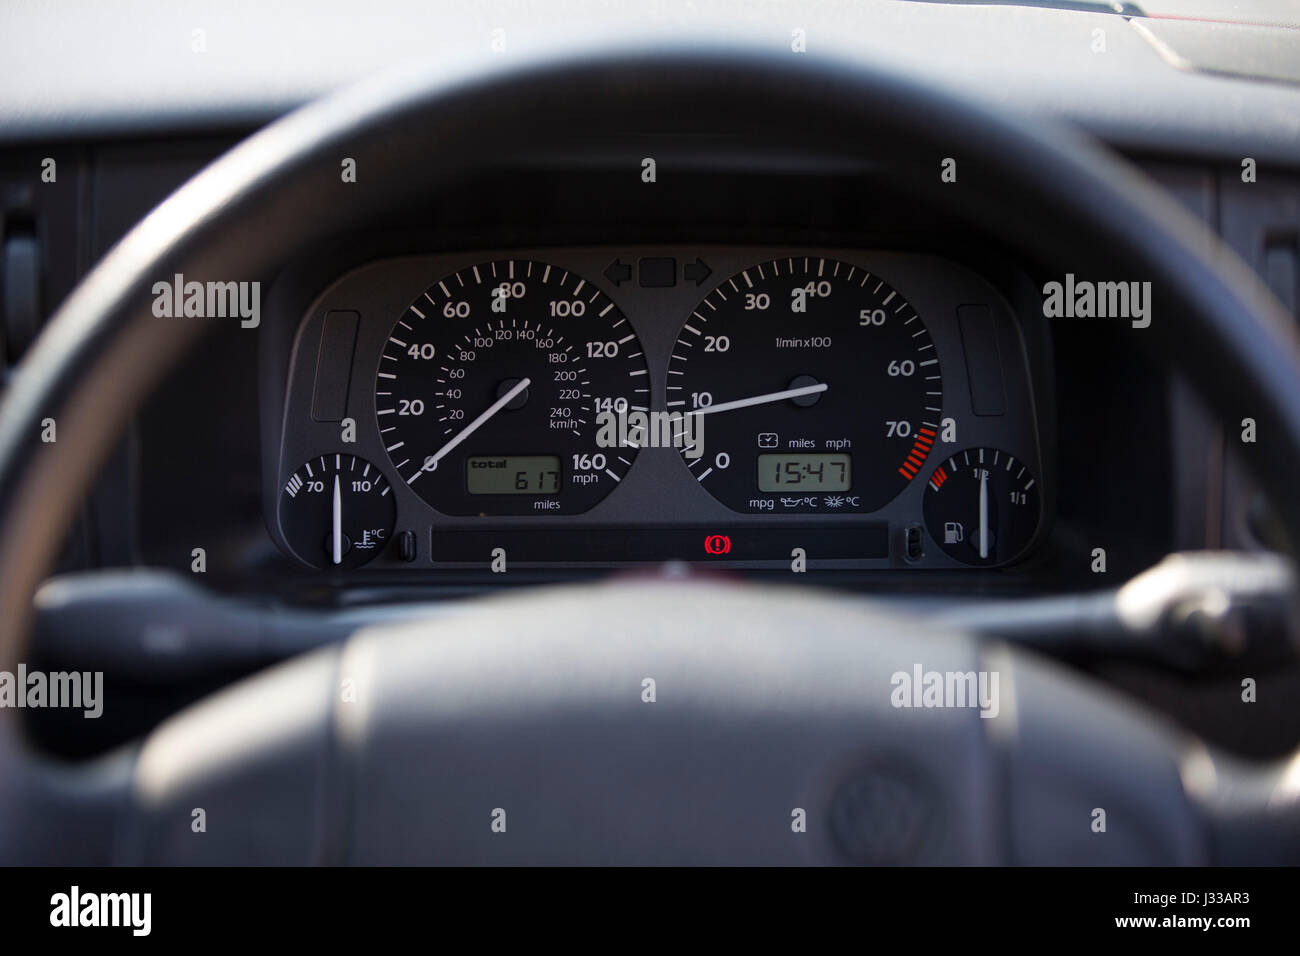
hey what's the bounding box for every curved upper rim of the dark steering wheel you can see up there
[0,42,1300,863]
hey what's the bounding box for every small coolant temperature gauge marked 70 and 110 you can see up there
[280,454,397,568]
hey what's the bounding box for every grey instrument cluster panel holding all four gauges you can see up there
[261,245,1053,576]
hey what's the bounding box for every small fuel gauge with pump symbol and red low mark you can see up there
[924,447,1039,564]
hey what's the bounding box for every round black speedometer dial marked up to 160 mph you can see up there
[374,260,650,515]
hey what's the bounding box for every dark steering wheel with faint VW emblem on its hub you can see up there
[0,40,1300,864]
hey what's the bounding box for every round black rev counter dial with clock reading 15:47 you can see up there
[667,256,943,514]
